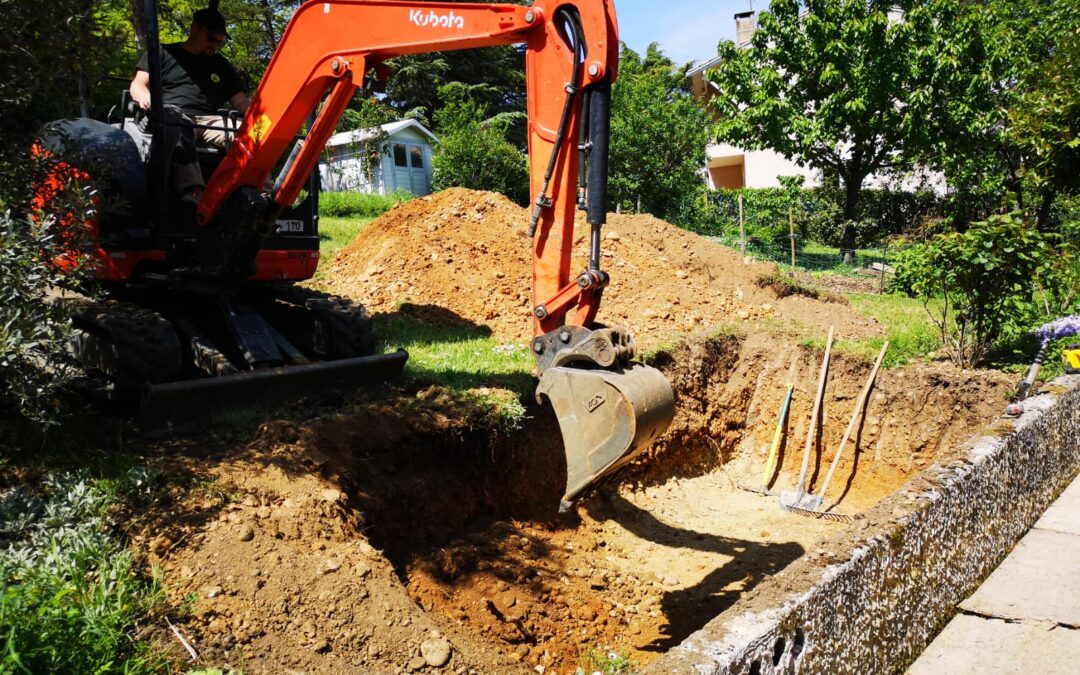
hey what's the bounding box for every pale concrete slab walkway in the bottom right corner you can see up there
[908,477,1080,675]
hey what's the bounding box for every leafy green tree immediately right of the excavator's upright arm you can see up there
[608,43,710,216]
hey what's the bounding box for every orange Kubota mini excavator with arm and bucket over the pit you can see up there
[43,0,674,508]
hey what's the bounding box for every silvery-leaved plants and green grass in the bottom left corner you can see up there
[0,469,168,673]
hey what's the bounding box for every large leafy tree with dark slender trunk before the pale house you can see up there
[707,0,977,258]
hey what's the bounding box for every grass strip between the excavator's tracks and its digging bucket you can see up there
[375,308,536,428]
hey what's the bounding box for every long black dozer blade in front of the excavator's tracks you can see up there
[138,349,408,430]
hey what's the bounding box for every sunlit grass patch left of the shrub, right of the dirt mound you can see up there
[845,294,942,367]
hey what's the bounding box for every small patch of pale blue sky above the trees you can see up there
[615,0,756,65]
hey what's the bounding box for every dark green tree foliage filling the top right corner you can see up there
[927,0,1080,231]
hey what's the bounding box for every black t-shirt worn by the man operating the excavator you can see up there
[136,42,244,114]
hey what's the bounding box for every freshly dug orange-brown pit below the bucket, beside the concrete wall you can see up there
[293,336,1008,672]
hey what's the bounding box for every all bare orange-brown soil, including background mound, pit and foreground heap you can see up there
[127,190,1012,673]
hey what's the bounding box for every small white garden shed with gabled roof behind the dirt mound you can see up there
[319,120,437,197]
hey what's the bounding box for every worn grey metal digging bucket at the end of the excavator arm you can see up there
[537,362,675,512]
